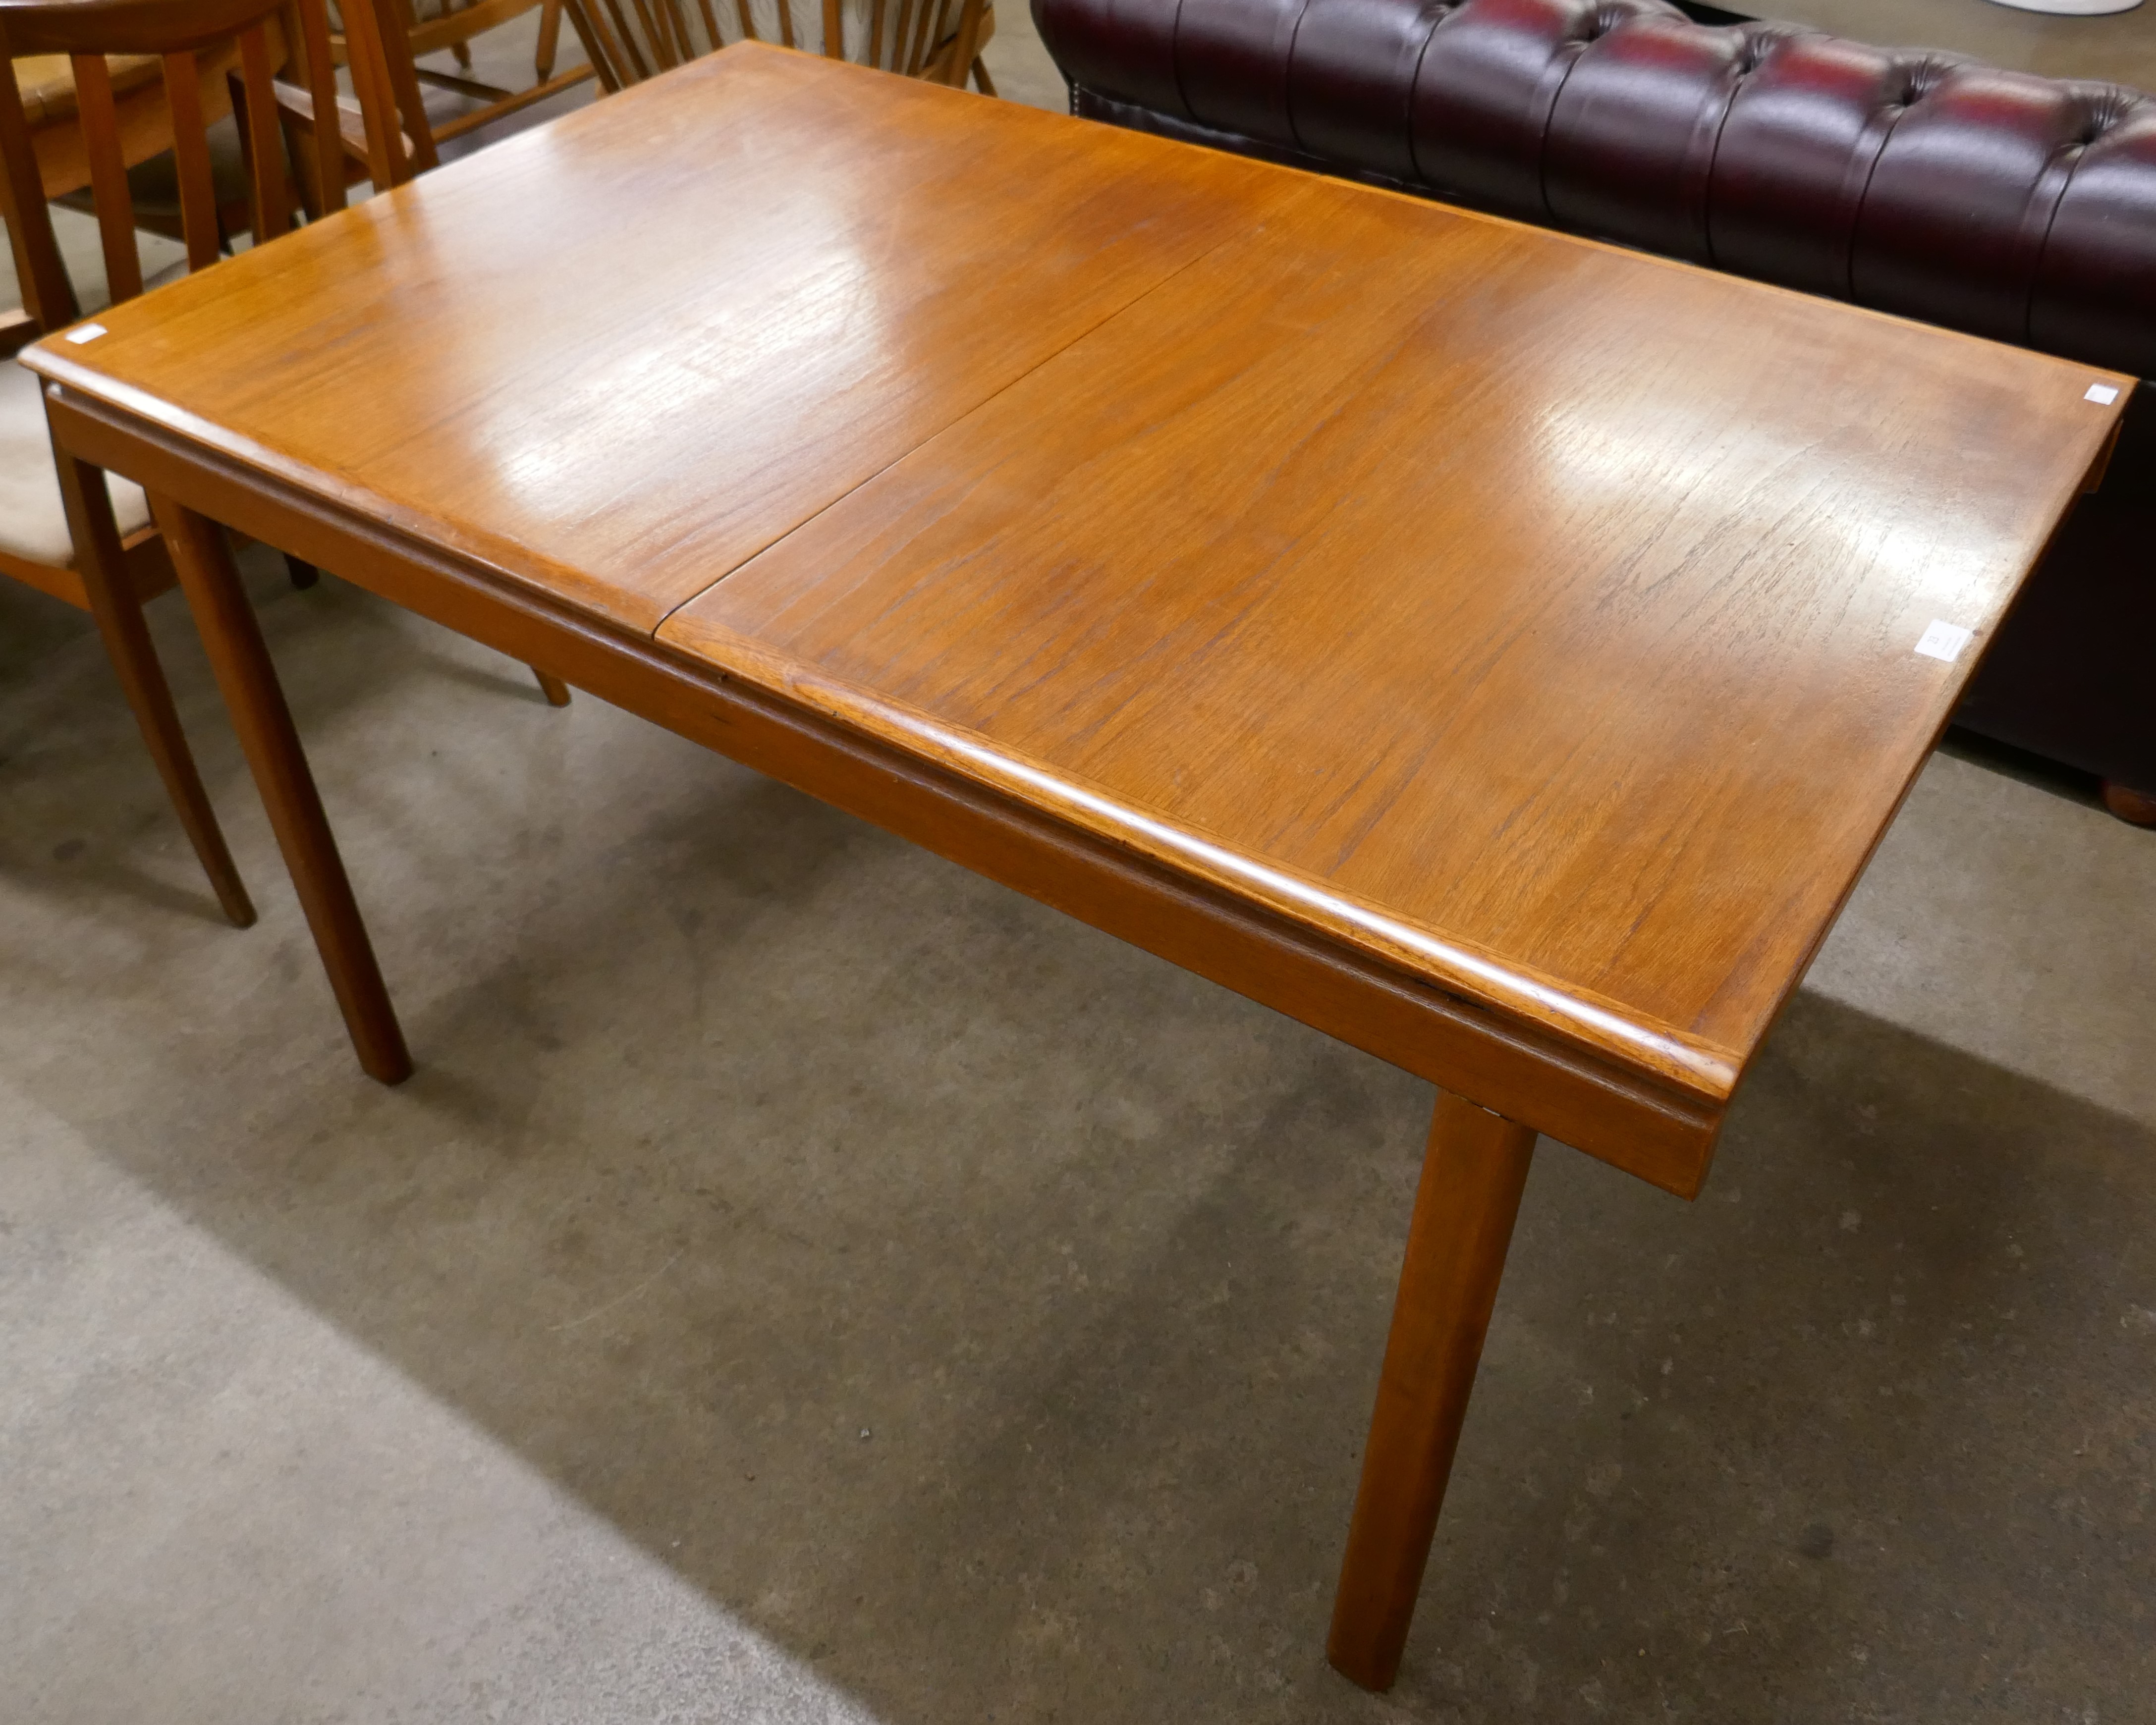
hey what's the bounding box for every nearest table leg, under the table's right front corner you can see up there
[1326,1091,1535,1688]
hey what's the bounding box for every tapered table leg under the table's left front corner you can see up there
[151,496,412,1084]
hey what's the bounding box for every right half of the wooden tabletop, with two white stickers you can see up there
[660,181,2124,1097]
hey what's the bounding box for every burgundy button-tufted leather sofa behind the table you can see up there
[1033,0,2156,819]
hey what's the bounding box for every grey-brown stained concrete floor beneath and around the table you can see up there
[0,3,2156,1725]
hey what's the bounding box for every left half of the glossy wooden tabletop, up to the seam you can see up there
[32,45,1291,630]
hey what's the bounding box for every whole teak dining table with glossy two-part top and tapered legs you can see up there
[26,48,2130,1688]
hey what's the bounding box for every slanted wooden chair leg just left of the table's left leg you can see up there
[54,448,254,929]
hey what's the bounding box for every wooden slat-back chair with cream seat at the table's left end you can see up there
[0,0,567,927]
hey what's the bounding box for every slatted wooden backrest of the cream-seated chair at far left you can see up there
[0,0,412,330]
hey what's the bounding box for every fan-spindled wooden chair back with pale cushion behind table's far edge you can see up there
[567,0,988,91]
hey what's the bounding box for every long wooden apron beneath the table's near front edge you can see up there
[45,384,1725,1197]
